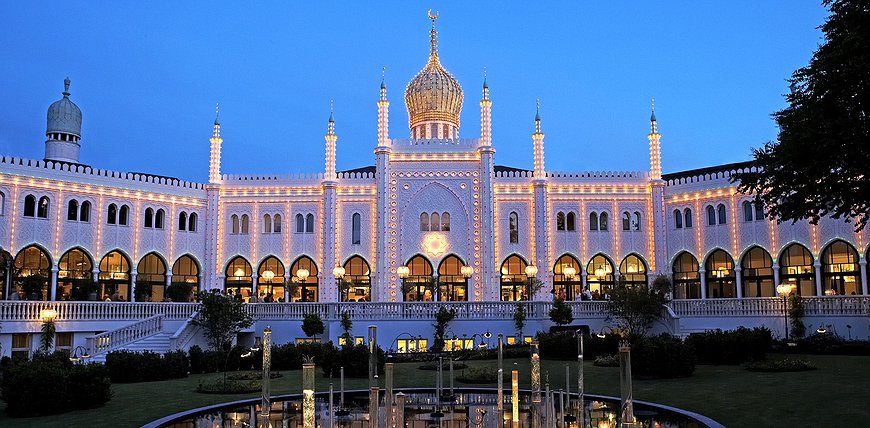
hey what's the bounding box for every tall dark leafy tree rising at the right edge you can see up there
[733,0,870,230]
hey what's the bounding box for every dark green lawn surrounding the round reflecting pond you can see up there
[0,355,870,427]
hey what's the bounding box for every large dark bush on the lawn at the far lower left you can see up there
[0,352,112,417]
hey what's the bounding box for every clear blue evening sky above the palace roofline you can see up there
[0,0,826,181]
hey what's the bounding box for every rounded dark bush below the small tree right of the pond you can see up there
[631,334,695,378]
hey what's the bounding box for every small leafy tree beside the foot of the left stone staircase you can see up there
[191,291,254,350]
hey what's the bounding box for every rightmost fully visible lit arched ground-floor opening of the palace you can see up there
[821,241,861,296]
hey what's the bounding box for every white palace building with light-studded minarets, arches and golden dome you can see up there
[0,19,870,355]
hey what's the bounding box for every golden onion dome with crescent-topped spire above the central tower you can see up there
[405,14,463,128]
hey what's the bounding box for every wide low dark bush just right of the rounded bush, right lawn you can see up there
[686,327,773,364]
